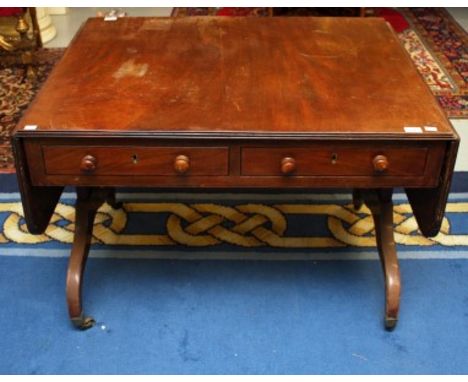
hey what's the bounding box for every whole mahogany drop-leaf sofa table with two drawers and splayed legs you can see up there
[13,17,459,329]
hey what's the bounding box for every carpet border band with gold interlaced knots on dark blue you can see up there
[0,187,468,259]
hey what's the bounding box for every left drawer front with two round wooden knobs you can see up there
[42,146,229,176]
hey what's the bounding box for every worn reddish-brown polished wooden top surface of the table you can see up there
[18,17,454,139]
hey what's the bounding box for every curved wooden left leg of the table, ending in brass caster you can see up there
[66,187,117,329]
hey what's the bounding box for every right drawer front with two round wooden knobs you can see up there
[241,147,428,177]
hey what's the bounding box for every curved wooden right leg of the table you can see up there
[363,189,401,330]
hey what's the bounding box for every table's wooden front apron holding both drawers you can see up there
[24,138,446,189]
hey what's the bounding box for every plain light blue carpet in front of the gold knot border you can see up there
[0,256,468,374]
